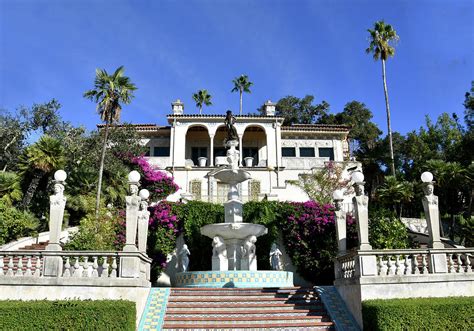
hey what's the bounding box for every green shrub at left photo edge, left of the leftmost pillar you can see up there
[0,200,39,245]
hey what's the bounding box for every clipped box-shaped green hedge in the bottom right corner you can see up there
[362,297,474,330]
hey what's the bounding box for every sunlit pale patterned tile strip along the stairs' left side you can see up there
[138,287,170,330]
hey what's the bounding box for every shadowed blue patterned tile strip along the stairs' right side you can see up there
[314,286,360,331]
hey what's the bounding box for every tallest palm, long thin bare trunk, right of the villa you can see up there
[365,21,399,176]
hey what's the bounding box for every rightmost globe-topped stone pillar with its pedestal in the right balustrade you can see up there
[421,172,448,273]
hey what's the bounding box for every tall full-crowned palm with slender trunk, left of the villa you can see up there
[84,66,137,214]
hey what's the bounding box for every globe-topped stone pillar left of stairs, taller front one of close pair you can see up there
[120,171,141,278]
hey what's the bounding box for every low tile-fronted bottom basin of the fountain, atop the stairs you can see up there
[174,270,293,288]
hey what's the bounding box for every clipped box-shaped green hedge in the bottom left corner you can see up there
[0,300,136,331]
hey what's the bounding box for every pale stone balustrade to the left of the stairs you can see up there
[0,250,151,281]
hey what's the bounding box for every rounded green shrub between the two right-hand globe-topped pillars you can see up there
[369,209,408,249]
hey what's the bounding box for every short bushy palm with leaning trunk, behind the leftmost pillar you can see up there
[19,135,66,209]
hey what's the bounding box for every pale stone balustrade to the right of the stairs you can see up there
[334,248,474,279]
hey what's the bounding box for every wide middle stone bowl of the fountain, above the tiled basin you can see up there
[201,223,268,240]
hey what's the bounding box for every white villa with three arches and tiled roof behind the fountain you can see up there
[118,100,360,203]
